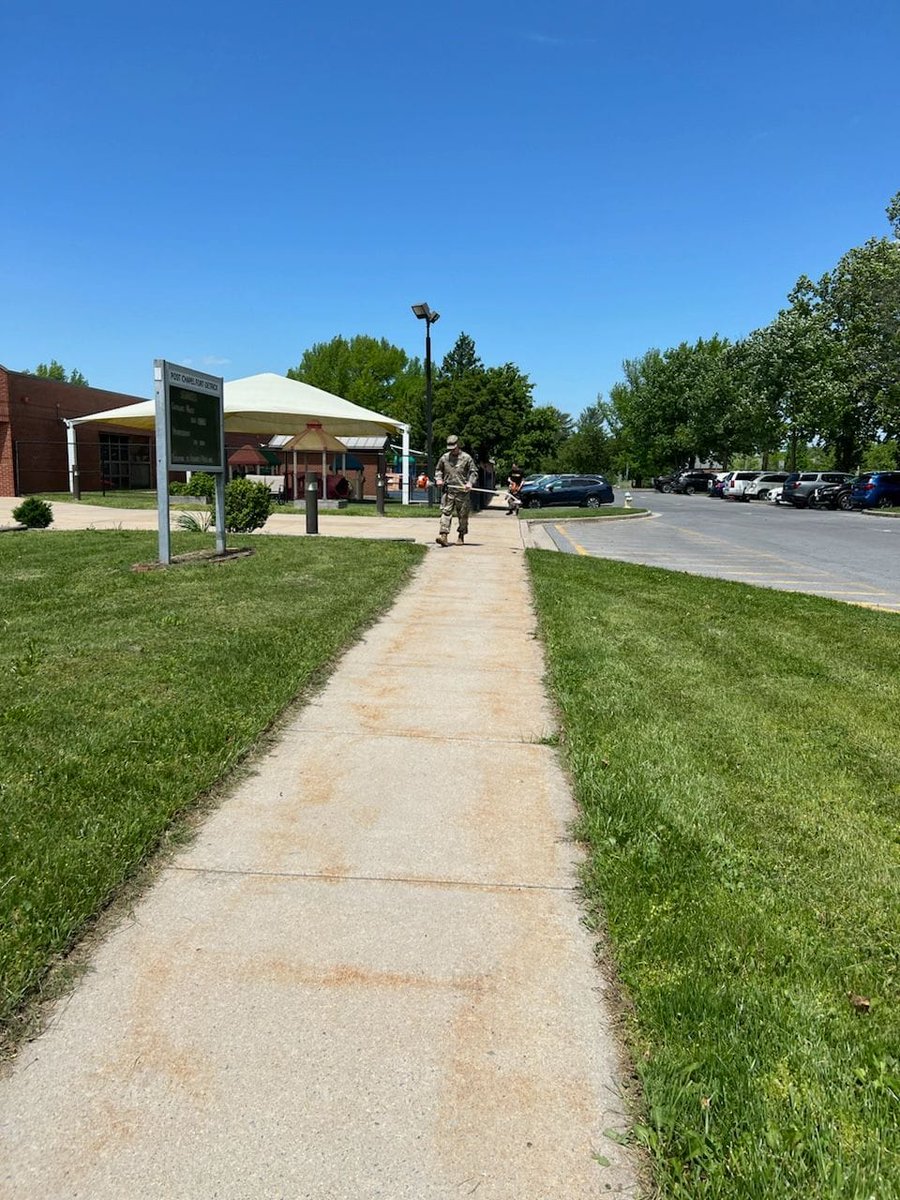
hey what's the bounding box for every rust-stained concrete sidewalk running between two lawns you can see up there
[0,511,638,1200]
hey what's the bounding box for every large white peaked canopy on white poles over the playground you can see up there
[66,372,409,504]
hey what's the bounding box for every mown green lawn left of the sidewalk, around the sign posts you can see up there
[0,532,422,1031]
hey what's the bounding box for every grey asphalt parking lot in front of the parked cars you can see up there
[546,491,900,612]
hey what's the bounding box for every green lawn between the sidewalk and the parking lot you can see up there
[529,551,900,1200]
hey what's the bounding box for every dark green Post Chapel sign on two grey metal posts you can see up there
[154,359,226,563]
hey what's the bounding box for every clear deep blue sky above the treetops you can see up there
[0,0,900,414]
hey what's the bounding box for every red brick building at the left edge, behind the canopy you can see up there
[0,366,156,496]
